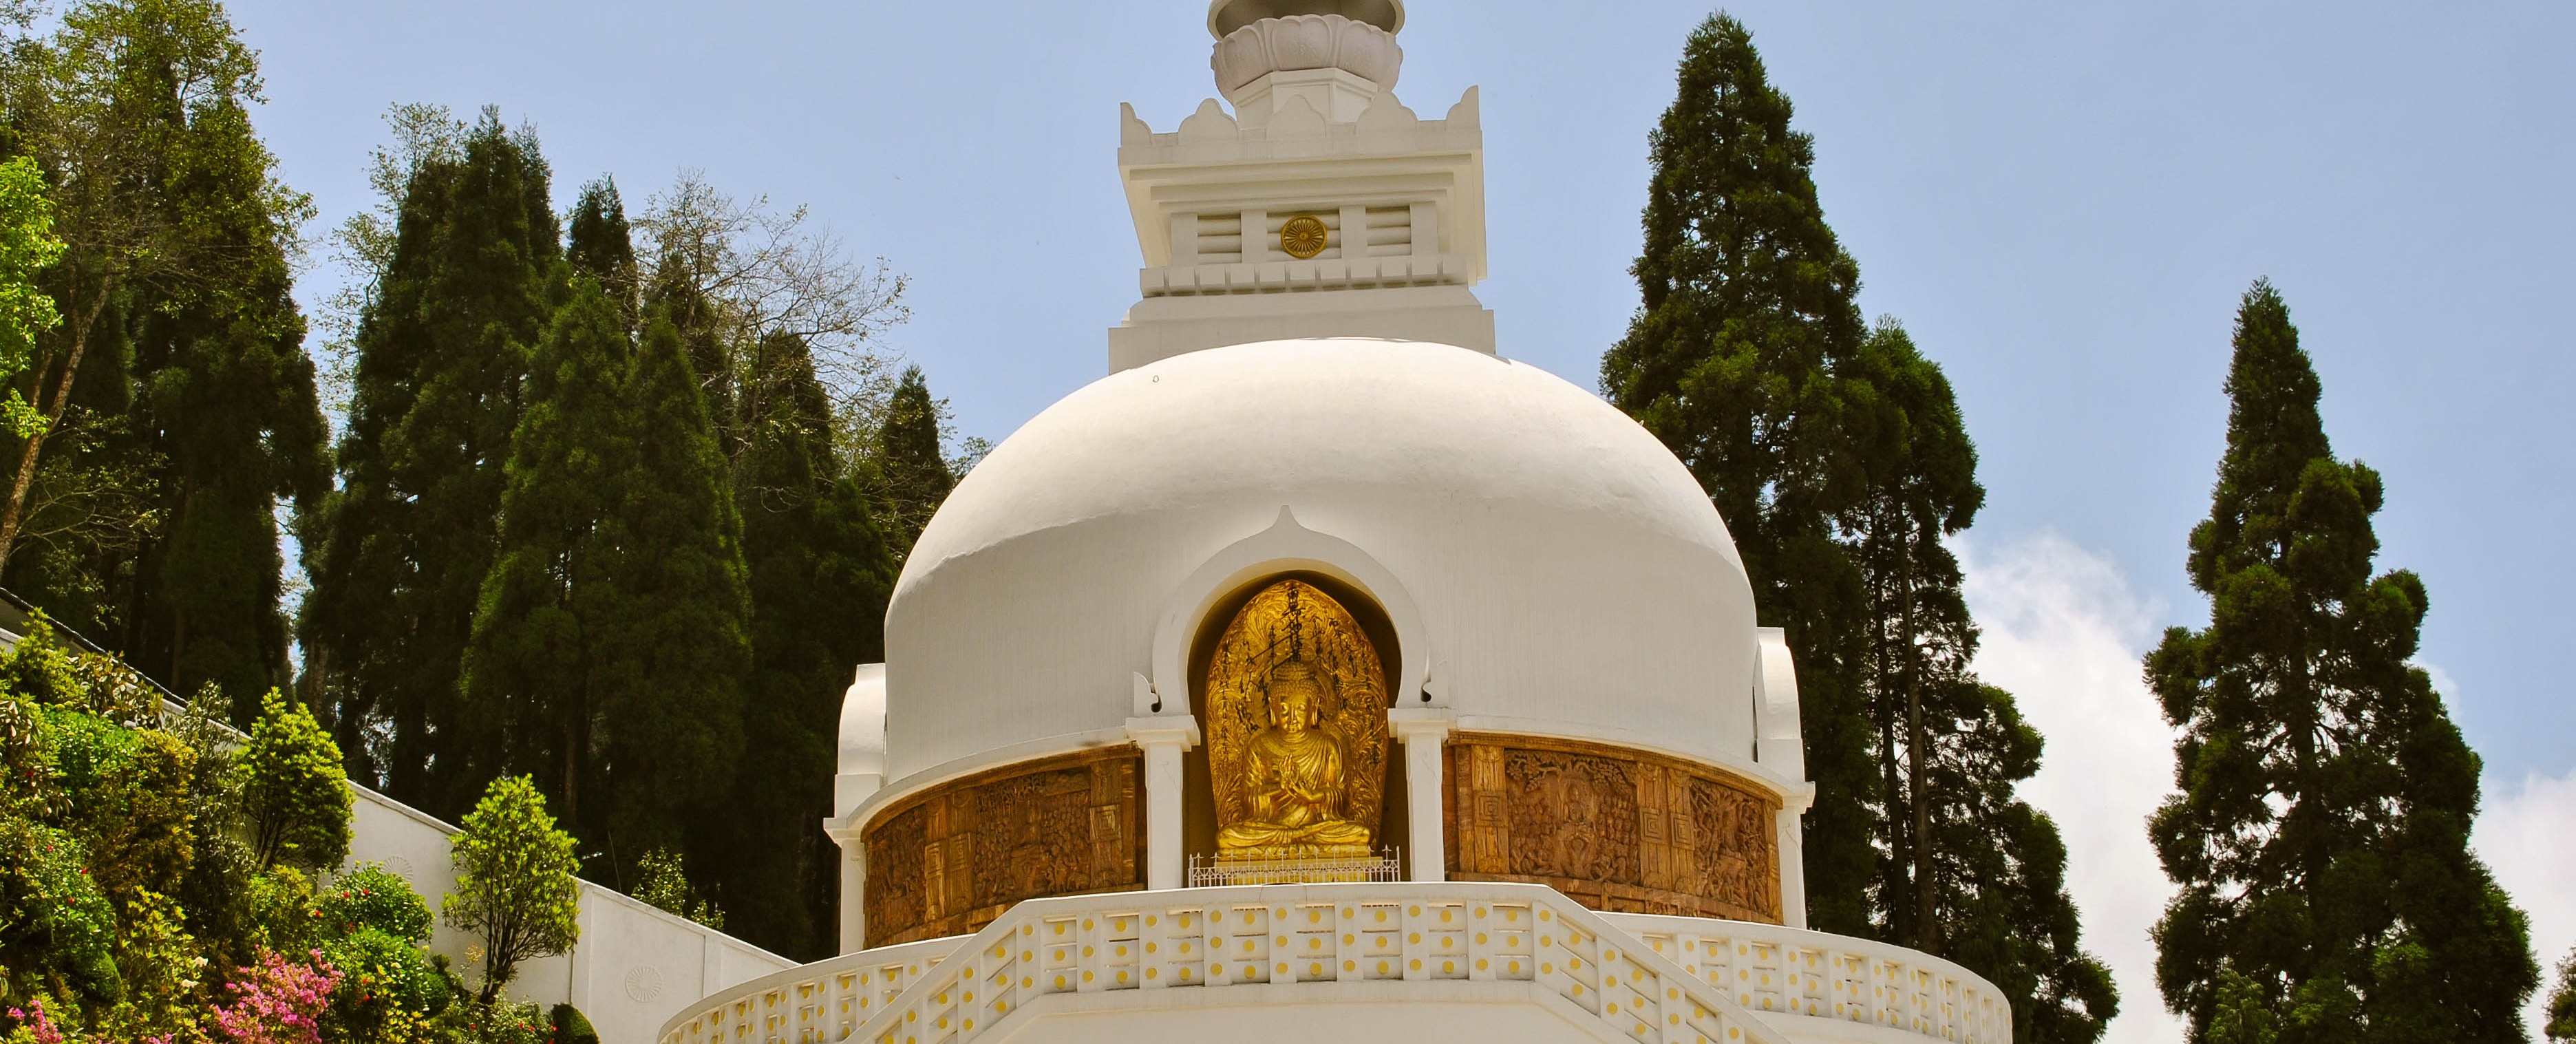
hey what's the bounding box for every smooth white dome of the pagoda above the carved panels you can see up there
[886,338,1757,786]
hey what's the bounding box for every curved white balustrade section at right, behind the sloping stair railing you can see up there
[1605,913,2012,1044]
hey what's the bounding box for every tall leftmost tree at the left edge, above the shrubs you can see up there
[0,0,330,725]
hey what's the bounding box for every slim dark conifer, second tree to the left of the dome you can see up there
[721,335,894,959]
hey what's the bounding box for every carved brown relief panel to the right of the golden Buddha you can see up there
[1440,732,1780,926]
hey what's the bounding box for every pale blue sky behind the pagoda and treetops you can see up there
[235,0,2576,1031]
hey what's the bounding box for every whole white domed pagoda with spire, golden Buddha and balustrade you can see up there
[659,0,2012,1044]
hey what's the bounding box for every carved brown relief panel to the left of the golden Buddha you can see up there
[863,745,1144,946]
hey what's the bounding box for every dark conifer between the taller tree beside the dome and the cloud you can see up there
[1842,322,2118,1044]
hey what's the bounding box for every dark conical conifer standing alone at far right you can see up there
[2146,281,2540,1044]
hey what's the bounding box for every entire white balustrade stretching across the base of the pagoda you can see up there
[659,882,2012,1044]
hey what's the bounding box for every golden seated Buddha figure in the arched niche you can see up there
[1216,660,1368,858]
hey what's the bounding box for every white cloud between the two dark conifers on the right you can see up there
[1952,531,2184,1044]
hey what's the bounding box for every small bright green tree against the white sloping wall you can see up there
[440,776,579,1005]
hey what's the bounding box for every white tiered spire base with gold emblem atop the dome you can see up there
[1110,0,1494,374]
